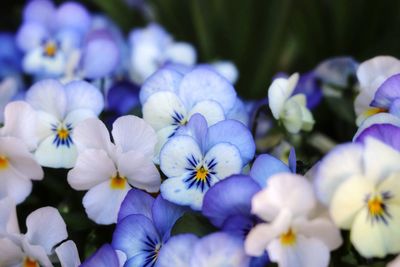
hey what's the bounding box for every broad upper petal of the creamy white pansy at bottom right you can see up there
[251,173,316,221]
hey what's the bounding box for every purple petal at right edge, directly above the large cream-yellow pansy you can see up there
[354,123,400,151]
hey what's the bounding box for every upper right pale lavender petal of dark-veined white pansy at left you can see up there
[65,81,104,115]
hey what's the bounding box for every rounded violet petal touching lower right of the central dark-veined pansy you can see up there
[203,175,261,227]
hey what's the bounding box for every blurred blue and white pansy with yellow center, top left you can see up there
[16,0,91,77]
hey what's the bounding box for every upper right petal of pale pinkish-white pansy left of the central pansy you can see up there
[112,115,157,158]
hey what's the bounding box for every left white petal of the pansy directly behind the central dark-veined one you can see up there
[142,92,186,131]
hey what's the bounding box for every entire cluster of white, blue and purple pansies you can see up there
[0,0,400,267]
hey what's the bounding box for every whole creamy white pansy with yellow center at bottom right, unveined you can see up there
[245,173,342,267]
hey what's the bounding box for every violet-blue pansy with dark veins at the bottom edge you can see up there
[112,189,185,267]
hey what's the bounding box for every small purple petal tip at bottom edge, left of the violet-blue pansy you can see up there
[80,244,120,267]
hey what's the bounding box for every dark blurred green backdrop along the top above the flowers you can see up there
[5,0,400,98]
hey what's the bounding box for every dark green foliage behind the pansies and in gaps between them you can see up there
[4,0,400,266]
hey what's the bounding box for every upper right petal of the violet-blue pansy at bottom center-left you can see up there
[152,195,187,242]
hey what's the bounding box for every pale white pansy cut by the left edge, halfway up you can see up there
[0,101,44,204]
